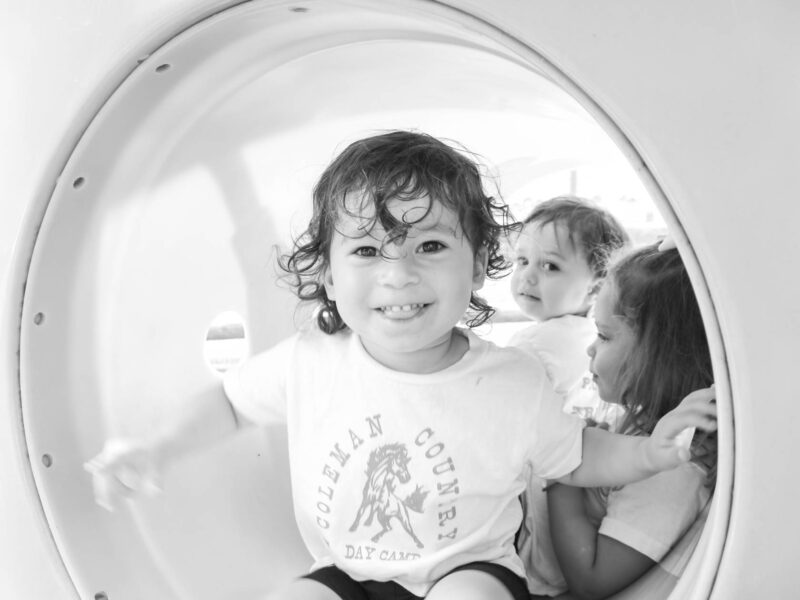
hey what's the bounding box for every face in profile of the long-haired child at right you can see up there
[586,283,636,404]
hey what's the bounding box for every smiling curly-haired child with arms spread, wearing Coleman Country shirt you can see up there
[84,131,714,600]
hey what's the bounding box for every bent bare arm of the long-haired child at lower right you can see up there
[547,484,655,599]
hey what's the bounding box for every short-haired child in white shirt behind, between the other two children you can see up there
[509,196,629,595]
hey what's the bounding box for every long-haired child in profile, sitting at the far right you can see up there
[548,246,716,598]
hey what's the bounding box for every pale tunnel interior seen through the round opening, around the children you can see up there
[20,1,724,600]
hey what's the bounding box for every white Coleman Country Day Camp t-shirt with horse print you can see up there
[225,331,583,596]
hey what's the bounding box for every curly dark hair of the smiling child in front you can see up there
[278,131,518,334]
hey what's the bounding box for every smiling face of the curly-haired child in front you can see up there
[324,198,486,372]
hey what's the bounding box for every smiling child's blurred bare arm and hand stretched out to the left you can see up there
[85,385,246,510]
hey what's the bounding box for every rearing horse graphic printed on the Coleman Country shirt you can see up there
[350,444,428,548]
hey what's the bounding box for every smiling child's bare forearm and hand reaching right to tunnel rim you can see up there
[558,387,717,487]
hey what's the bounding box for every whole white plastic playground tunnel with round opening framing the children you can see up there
[0,0,800,600]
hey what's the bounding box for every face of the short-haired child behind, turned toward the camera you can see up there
[511,222,598,321]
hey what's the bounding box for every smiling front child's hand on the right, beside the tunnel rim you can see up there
[645,385,717,472]
